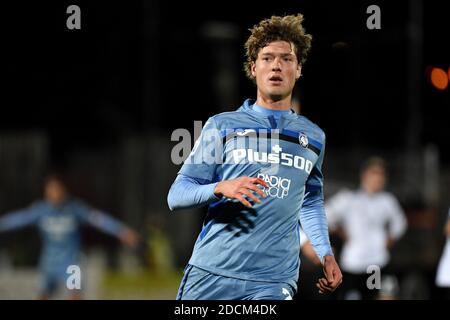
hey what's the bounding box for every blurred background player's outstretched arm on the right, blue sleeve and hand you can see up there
[79,205,139,247]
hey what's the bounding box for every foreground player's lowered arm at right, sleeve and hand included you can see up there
[300,134,342,293]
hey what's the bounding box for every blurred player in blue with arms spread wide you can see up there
[0,175,138,300]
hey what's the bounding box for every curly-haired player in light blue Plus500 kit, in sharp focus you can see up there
[168,14,342,300]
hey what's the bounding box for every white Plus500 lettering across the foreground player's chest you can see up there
[232,149,313,173]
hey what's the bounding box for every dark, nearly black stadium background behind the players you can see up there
[0,0,450,300]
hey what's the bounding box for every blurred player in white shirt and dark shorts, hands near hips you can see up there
[325,157,407,300]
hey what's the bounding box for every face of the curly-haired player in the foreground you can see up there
[252,41,301,101]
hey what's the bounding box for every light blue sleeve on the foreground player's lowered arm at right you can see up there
[300,136,333,262]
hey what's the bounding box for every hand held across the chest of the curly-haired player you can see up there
[214,177,269,208]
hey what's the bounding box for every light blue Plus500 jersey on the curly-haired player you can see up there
[168,100,333,288]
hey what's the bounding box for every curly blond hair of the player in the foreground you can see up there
[244,13,312,81]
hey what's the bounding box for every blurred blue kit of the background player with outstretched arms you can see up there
[0,199,124,291]
